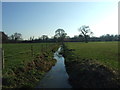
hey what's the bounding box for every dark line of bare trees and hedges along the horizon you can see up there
[3,25,120,43]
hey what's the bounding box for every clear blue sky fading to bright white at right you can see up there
[2,2,118,39]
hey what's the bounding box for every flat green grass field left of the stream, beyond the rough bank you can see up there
[3,43,53,69]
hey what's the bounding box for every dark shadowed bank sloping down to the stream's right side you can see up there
[63,46,120,88]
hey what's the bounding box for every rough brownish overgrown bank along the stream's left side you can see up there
[2,45,58,89]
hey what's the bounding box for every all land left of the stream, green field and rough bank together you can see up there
[3,43,58,88]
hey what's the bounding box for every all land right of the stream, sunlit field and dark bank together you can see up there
[64,42,120,88]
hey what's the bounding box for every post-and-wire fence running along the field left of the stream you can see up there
[2,43,57,69]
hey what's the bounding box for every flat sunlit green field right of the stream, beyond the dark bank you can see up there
[65,42,120,69]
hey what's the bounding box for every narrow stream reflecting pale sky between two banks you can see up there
[37,47,72,88]
